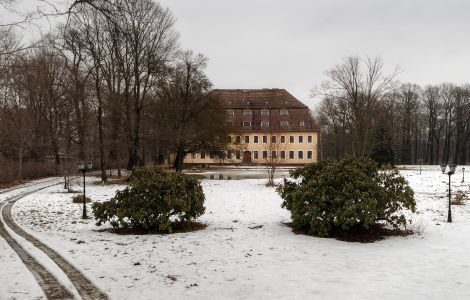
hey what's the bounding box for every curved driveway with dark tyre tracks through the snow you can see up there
[0,184,108,299]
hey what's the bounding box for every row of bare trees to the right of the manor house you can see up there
[314,57,470,165]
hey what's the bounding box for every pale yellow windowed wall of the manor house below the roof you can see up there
[184,131,318,165]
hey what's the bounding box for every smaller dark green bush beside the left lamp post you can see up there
[92,168,205,232]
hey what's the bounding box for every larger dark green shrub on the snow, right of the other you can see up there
[278,156,416,236]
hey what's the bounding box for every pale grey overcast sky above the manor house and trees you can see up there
[160,0,470,106]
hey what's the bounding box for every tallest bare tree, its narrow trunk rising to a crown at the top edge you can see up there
[101,0,178,169]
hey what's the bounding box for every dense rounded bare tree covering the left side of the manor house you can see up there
[155,51,227,171]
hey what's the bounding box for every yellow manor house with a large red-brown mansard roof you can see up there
[185,89,319,165]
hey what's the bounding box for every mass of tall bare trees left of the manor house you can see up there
[0,0,226,182]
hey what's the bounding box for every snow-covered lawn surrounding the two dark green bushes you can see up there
[0,166,470,299]
